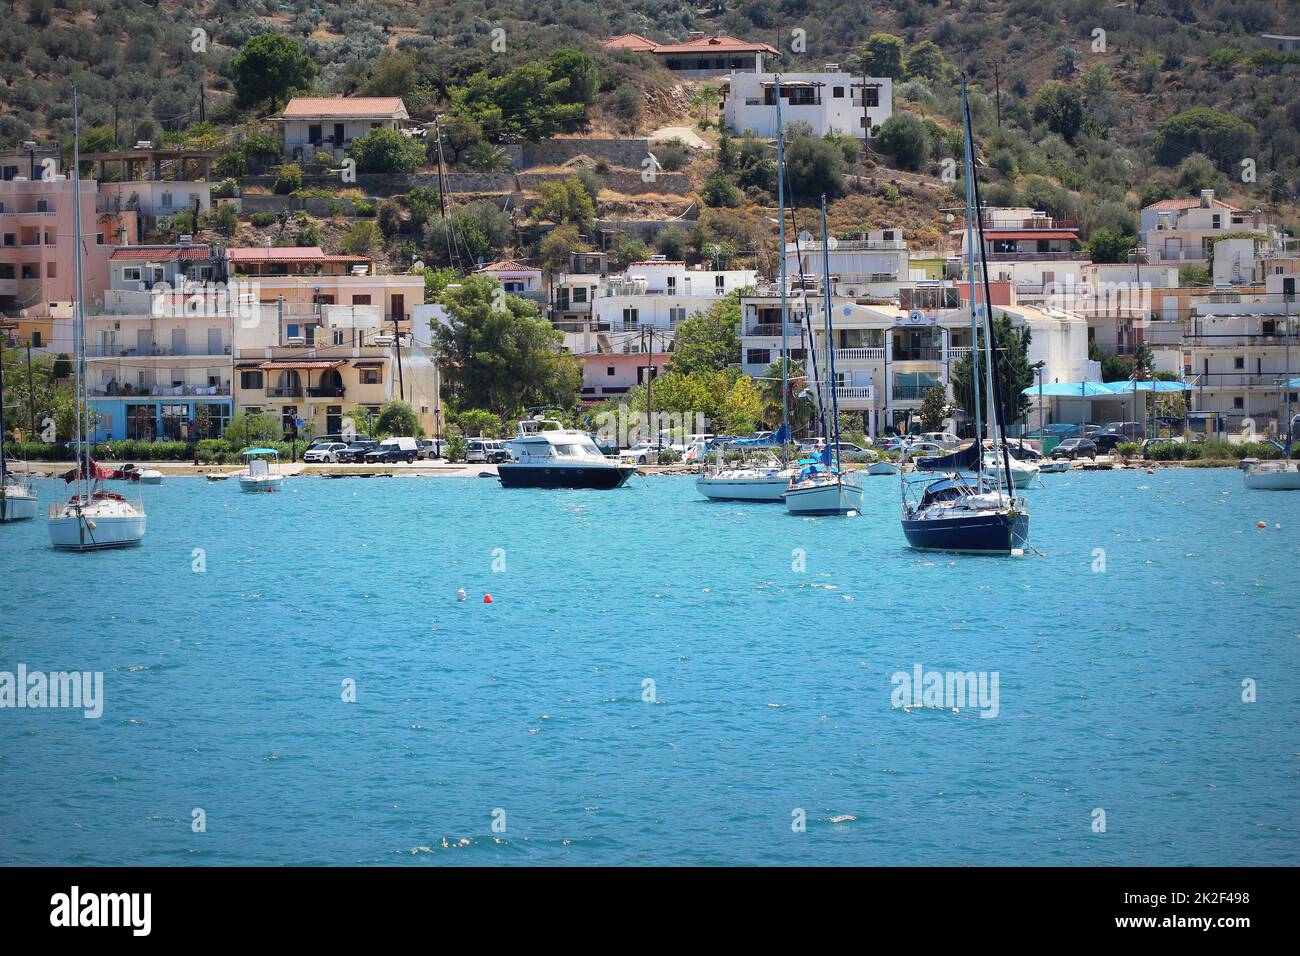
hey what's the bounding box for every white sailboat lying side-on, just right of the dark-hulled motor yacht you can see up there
[696,74,796,502]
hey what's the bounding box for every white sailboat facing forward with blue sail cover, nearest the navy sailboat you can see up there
[781,195,862,515]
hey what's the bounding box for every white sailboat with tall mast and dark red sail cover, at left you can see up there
[47,86,146,551]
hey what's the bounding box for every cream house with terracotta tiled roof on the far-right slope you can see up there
[1140,189,1281,270]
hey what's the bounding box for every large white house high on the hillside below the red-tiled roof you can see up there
[722,64,893,139]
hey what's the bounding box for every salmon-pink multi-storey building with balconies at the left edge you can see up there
[0,174,116,316]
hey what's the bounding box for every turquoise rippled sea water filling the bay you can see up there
[0,470,1300,865]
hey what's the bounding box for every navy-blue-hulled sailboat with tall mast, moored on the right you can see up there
[901,77,1030,554]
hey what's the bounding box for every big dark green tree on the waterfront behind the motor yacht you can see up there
[433,274,581,415]
